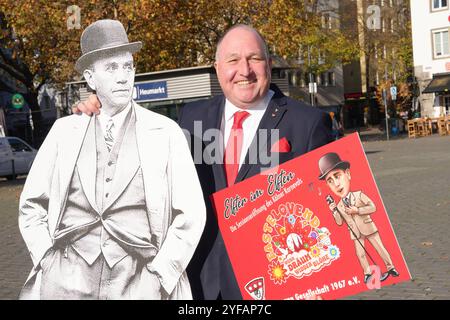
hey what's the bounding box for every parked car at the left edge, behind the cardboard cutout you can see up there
[0,137,37,180]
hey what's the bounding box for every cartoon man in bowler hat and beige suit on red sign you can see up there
[319,152,399,283]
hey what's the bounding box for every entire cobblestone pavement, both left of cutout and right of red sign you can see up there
[0,136,450,299]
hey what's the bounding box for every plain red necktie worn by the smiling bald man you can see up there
[224,111,250,186]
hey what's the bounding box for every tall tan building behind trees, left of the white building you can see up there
[339,0,408,127]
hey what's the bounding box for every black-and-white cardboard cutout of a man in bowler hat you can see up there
[19,20,206,299]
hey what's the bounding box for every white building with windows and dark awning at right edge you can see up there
[411,0,450,117]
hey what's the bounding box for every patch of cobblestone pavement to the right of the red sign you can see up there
[350,135,450,300]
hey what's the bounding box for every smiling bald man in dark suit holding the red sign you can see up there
[74,25,331,299]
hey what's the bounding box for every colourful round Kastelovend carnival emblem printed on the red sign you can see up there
[262,202,340,284]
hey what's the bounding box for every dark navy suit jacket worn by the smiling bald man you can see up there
[179,85,332,299]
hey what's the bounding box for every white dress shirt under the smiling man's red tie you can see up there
[220,90,274,169]
